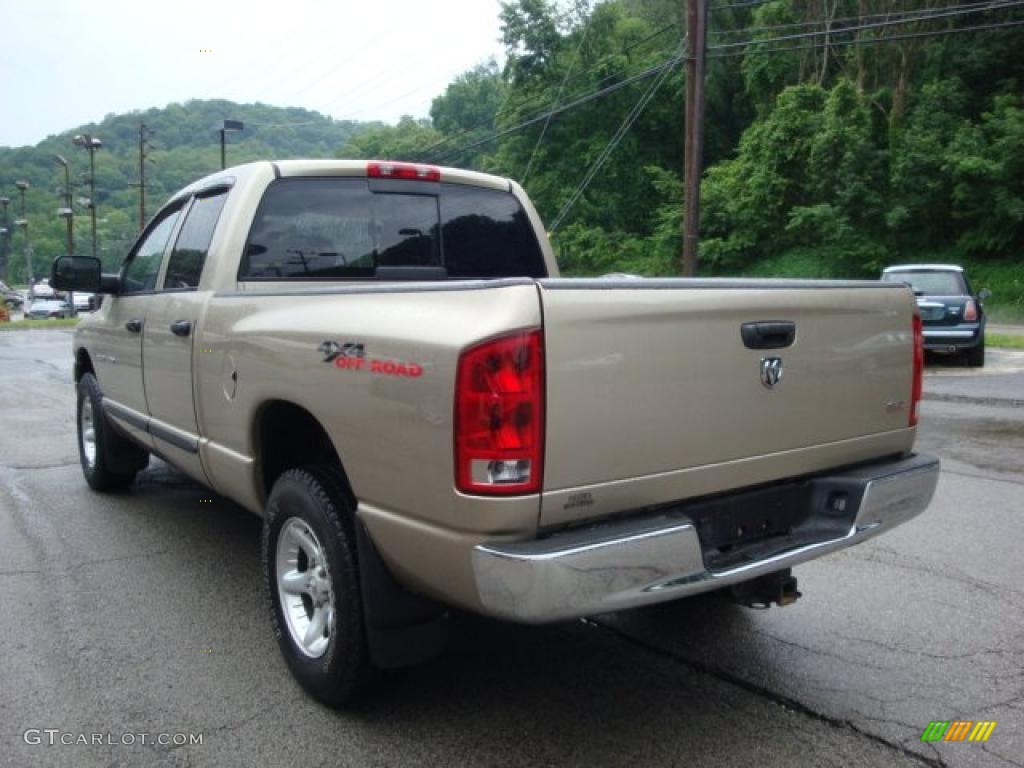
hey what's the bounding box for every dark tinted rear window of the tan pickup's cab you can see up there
[239,178,547,281]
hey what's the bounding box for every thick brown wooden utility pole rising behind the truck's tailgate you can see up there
[682,0,708,278]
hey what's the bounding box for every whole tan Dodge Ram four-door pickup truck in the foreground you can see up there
[53,161,938,706]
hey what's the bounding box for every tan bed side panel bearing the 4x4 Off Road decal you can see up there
[197,281,541,534]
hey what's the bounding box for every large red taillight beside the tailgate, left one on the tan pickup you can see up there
[455,331,544,496]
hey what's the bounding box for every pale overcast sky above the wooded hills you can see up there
[0,0,502,146]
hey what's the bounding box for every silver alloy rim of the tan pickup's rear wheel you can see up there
[274,517,335,658]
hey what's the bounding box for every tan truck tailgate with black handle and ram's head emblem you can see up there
[540,280,914,525]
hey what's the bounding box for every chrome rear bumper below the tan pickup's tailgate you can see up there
[473,456,939,624]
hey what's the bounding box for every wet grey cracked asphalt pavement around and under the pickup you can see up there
[0,331,1024,768]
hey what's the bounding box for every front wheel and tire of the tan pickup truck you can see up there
[76,374,150,490]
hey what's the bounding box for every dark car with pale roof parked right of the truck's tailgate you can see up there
[882,264,992,368]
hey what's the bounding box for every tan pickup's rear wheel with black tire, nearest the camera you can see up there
[262,466,371,708]
